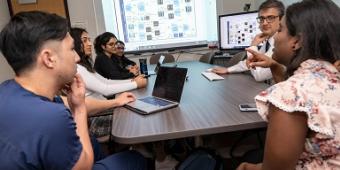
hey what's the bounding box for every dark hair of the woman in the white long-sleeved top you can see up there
[70,27,95,73]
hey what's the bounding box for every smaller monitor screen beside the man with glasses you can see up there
[219,11,261,50]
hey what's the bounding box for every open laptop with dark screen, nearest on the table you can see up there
[124,66,188,114]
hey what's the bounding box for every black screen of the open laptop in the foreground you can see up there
[152,66,187,102]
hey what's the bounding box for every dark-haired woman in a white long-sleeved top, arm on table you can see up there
[71,28,147,99]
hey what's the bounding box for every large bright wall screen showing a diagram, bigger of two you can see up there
[102,0,218,52]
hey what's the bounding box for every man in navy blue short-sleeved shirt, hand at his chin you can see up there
[0,11,145,169]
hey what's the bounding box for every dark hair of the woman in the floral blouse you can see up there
[286,0,340,73]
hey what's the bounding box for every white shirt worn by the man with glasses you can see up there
[228,37,274,81]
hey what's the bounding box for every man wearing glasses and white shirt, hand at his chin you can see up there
[212,0,285,81]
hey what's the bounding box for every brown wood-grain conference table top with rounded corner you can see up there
[112,61,268,144]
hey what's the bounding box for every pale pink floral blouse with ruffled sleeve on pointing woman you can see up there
[255,59,340,170]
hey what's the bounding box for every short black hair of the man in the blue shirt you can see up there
[0,11,69,75]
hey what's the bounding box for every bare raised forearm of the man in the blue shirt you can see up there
[73,105,94,169]
